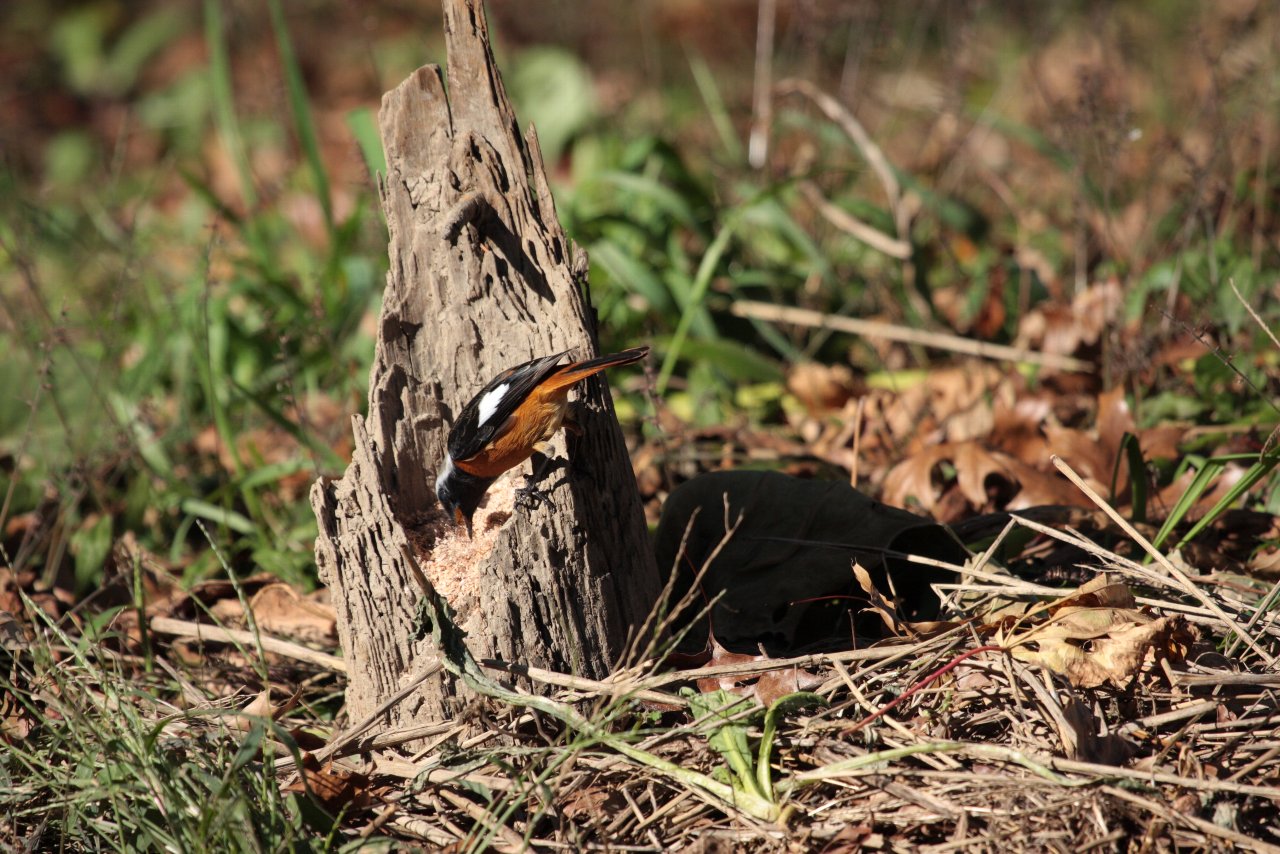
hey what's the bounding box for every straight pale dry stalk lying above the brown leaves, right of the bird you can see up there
[730,300,1093,374]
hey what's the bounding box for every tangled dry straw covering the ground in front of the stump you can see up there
[240,512,1280,851]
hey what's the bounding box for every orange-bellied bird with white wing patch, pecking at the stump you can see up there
[435,347,649,538]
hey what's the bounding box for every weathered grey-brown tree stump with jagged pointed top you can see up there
[304,0,658,729]
